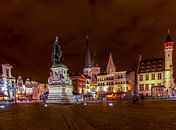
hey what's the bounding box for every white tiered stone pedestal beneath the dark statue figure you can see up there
[46,64,76,104]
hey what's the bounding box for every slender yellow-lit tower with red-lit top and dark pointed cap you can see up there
[164,30,174,96]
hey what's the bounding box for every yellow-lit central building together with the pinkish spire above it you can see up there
[97,53,135,96]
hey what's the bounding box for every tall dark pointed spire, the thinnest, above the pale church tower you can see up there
[84,35,92,68]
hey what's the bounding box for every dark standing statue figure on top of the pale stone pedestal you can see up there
[52,36,63,65]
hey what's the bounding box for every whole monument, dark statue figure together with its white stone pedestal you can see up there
[46,37,76,104]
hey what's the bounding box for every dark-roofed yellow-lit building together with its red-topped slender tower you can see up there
[137,33,175,96]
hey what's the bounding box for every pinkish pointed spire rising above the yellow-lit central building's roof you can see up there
[106,52,116,74]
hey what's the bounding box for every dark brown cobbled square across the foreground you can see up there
[0,101,176,130]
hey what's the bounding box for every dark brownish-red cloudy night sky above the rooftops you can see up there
[0,0,176,83]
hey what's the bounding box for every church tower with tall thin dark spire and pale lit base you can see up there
[83,35,92,77]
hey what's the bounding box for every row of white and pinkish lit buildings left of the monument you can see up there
[0,64,47,102]
